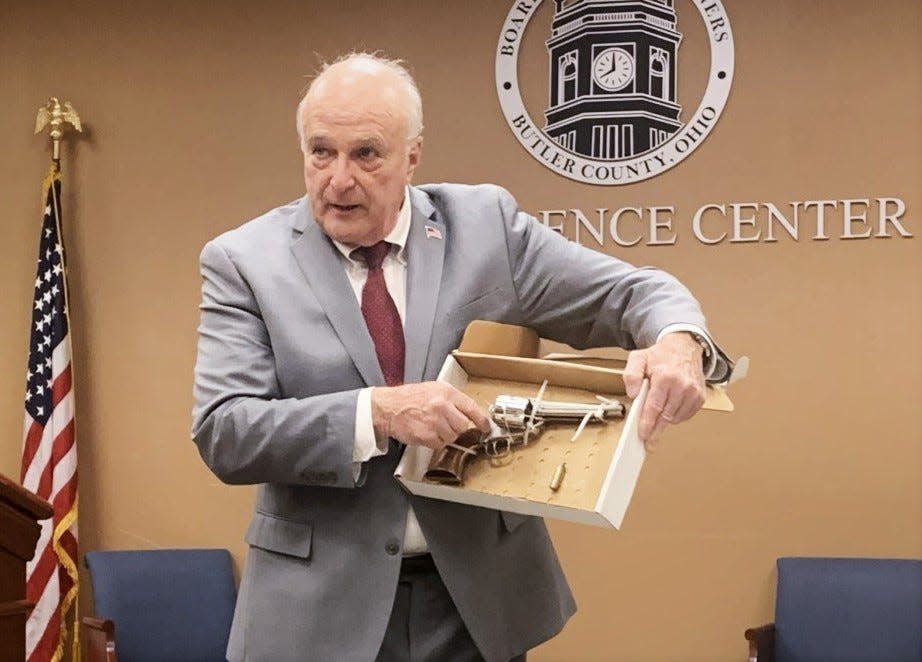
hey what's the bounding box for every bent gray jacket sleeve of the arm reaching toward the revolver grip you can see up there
[192,241,359,487]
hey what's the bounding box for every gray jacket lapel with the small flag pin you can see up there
[403,187,449,384]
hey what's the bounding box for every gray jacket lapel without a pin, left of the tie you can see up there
[291,198,385,386]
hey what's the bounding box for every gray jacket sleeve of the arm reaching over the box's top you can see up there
[498,189,707,349]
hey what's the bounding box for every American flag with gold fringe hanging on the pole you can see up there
[22,168,77,662]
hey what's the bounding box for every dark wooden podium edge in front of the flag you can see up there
[0,474,53,660]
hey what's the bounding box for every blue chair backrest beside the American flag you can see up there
[84,549,237,662]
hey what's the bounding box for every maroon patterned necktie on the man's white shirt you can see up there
[352,241,405,386]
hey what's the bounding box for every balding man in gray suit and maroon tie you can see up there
[193,54,725,662]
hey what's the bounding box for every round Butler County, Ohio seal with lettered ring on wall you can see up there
[496,0,733,186]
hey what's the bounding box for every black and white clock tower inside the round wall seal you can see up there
[544,0,683,159]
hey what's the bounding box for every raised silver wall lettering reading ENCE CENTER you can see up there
[538,197,913,247]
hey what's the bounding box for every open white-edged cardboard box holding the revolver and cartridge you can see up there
[395,322,733,528]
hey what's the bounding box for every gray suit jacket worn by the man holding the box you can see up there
[193,184,704,662]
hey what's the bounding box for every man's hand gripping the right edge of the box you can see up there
[624,331,705,449]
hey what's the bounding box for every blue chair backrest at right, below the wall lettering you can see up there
[775,558,922,662]
